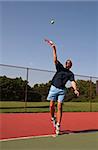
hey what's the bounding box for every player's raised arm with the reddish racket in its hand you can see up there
[45,39,58,64]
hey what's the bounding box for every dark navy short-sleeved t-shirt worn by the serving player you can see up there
[52,61,74,89]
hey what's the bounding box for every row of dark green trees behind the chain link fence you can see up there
[0,76,96,101]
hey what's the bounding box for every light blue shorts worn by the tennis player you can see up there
[47,85,66,103]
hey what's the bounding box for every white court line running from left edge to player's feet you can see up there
[0,134,56,142]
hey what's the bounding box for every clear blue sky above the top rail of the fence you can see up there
[0,1,98,76]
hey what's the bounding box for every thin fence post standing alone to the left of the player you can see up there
[24,68,29,112]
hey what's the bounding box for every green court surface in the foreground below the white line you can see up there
[0,132,98,150]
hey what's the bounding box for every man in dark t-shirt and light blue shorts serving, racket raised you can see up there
[45,40,79,134]
